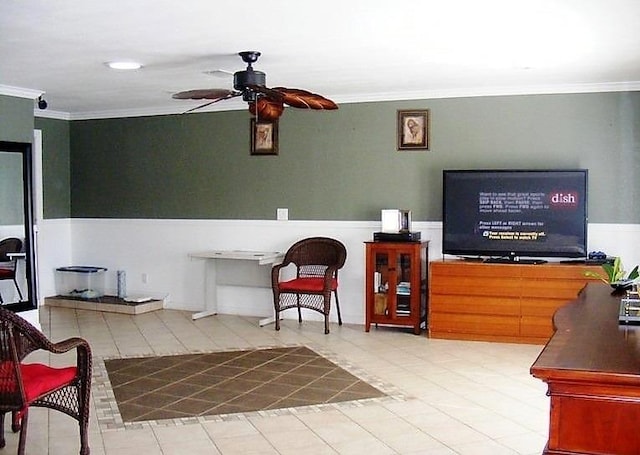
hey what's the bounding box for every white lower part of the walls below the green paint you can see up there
[33,219,640,324]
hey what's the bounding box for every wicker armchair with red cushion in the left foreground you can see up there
[0,308,91,455]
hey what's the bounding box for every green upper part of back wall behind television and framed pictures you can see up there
[60,92,640,223]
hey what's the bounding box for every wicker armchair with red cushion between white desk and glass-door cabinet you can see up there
[271,237,347,334]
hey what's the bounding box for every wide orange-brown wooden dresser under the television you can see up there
[428,260,603,344]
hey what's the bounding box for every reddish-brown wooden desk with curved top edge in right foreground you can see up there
[531,283,640,455]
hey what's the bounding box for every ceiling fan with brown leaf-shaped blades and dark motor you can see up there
[172,51,338,121]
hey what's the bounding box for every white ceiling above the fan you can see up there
[0,0,640,119]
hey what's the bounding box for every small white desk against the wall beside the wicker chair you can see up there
[189,250,284,327]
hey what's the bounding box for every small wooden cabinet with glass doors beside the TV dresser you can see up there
[365,242,428,335]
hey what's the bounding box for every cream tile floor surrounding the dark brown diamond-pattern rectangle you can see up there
[6,307,549,455]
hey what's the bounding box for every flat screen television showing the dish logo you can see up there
[442,169,588,262]
